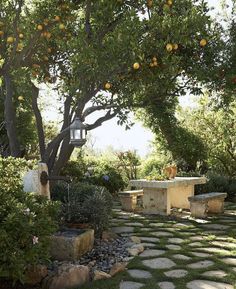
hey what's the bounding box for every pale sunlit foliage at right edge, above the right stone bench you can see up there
[179,96,236,177]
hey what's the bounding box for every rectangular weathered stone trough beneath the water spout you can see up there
[50,228,94,261]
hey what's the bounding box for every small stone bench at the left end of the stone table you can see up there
[119,190,143,212]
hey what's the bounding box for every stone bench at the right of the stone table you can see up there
[188,192,227,218]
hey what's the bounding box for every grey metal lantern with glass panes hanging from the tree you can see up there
[70,117,87,147]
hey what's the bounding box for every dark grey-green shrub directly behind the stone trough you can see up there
[51,182,112,236]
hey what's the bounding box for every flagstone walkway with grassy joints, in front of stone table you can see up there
[80,204,236,289]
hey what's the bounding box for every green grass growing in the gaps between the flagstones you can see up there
[84,207,236,289]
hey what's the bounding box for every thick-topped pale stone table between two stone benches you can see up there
[130,177,206,215]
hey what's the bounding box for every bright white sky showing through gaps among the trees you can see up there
[42,0,230,157]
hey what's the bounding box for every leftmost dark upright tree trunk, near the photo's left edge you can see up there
[4,73,21,157]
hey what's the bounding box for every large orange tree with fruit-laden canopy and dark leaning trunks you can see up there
[1,0,229,174]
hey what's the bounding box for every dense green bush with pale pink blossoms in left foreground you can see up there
[0,158,58,281]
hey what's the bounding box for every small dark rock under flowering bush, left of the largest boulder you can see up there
[26,265,48,285]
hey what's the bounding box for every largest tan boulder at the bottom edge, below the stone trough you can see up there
[43,264,89,289]
